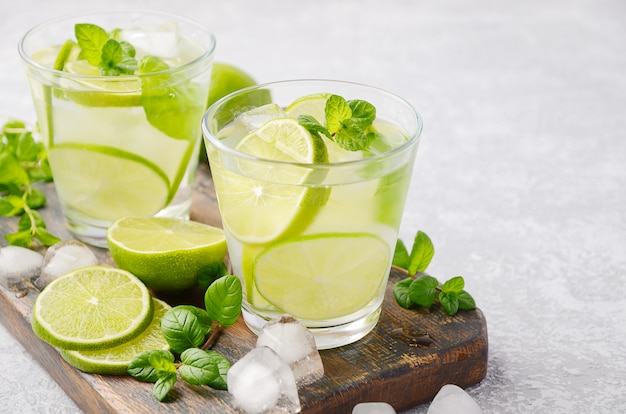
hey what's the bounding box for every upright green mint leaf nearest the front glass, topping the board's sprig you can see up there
[204,275,242,327]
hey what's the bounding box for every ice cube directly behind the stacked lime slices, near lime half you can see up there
[34,240,98,289]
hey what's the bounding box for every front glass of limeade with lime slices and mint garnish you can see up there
[202,80,422,349]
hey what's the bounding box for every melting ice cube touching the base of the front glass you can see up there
[256,315,324,385]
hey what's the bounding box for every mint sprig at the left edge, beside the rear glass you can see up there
[0,121,60,247]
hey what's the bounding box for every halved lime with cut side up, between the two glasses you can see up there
[107,217,226,292]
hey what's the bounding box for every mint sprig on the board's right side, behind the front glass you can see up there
[393,231,476,316]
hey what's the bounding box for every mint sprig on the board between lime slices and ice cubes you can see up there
[128,275,242,401]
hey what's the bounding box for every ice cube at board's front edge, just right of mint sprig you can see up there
[226,346,300,414]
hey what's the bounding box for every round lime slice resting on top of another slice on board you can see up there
[32,266,153,350]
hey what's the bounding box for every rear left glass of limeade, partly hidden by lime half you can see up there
[19,11,215,247]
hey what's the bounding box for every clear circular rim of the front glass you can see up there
[202,78,423,168]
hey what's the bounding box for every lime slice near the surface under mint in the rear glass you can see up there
[61,60,141,107]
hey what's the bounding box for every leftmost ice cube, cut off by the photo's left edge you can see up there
[0,246,44,290]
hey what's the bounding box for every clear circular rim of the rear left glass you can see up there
[17,8,217,82]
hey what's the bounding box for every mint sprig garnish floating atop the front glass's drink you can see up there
[298,95,377,151]
